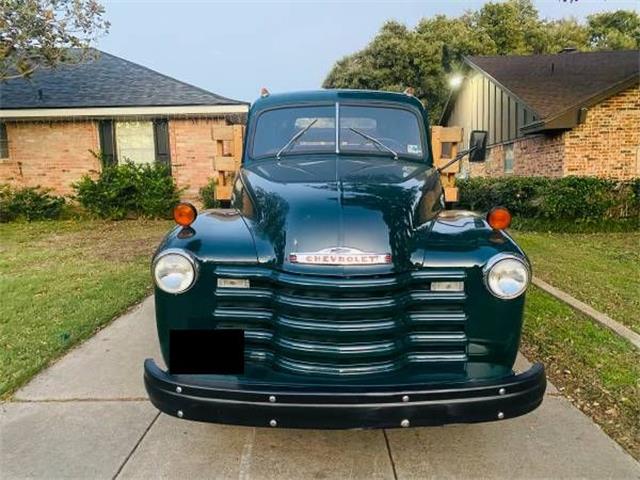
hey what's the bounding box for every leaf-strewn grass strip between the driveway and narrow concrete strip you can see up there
[522,287,640,459]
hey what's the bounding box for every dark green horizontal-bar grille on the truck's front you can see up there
[213,266,467,376]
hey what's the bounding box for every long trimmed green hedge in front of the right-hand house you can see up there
[458,177,640,231]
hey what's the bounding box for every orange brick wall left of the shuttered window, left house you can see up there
[0,121,100,195]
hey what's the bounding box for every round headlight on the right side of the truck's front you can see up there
[484,253,531,299]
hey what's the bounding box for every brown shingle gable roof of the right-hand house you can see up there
[443,50,640,133]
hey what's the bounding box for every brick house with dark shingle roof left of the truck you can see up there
[0,51,248,198]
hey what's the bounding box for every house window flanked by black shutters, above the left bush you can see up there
[99,120,170,165]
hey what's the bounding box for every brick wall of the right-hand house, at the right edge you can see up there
[563,86,640,179]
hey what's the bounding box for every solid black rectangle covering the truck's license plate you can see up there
[169,329,244,375]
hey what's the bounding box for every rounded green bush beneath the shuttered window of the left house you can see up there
[73,162,180,220]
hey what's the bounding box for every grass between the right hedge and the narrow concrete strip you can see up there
[514,232,640,333]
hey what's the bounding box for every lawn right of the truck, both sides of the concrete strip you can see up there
[514,232,640,459]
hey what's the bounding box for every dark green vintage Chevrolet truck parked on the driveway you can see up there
[144,90,546,429]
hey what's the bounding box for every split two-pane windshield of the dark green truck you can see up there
[252,105,424,159]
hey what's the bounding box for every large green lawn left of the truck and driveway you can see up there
[0,220,170,398]
